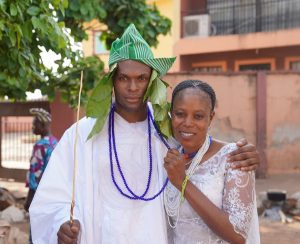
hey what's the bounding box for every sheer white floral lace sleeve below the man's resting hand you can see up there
[223,160,255,239]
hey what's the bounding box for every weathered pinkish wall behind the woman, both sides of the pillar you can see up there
[164,73,300,174]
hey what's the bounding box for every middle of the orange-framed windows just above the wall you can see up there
[234,59,275,71]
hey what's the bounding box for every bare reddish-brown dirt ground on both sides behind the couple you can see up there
[0,173,300,244]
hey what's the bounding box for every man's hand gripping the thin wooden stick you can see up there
[57,220,80,244]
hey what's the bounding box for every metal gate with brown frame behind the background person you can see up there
[0,101,50,182]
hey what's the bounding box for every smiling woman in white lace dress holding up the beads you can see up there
[164,80,260,244]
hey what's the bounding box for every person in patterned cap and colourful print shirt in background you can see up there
[24,108,58,243]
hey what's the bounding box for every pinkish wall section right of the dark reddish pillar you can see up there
[267,74,300,172]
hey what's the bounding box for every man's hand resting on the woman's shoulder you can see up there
[227,138,260,171]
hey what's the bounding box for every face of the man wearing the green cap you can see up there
[114,60,151,116]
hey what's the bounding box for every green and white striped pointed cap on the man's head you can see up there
[108,24,176,76]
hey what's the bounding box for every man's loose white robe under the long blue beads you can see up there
[30,113,168,244]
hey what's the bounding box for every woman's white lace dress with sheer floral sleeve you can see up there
[167,143,260,244]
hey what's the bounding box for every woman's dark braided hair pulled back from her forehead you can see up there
[171,80,216,111]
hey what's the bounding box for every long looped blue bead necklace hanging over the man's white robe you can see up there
[108,104,170,201]
